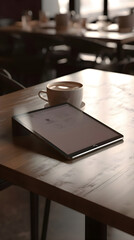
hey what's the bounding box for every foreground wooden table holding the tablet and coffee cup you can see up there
[0,69,134,240]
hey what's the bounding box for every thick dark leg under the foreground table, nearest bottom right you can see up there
[85,216,107,240]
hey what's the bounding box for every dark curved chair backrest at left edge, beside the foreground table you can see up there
[0,69,25,96]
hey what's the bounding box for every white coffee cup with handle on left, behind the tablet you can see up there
[38,81,83,107]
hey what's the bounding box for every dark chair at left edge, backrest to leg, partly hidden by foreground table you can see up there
[0,69,39,240]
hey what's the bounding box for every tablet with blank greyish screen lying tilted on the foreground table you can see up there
[12,103,123,159]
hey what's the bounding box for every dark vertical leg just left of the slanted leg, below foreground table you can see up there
[30,192,39,240]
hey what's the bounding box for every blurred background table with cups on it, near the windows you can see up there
[0,21,134,60]
